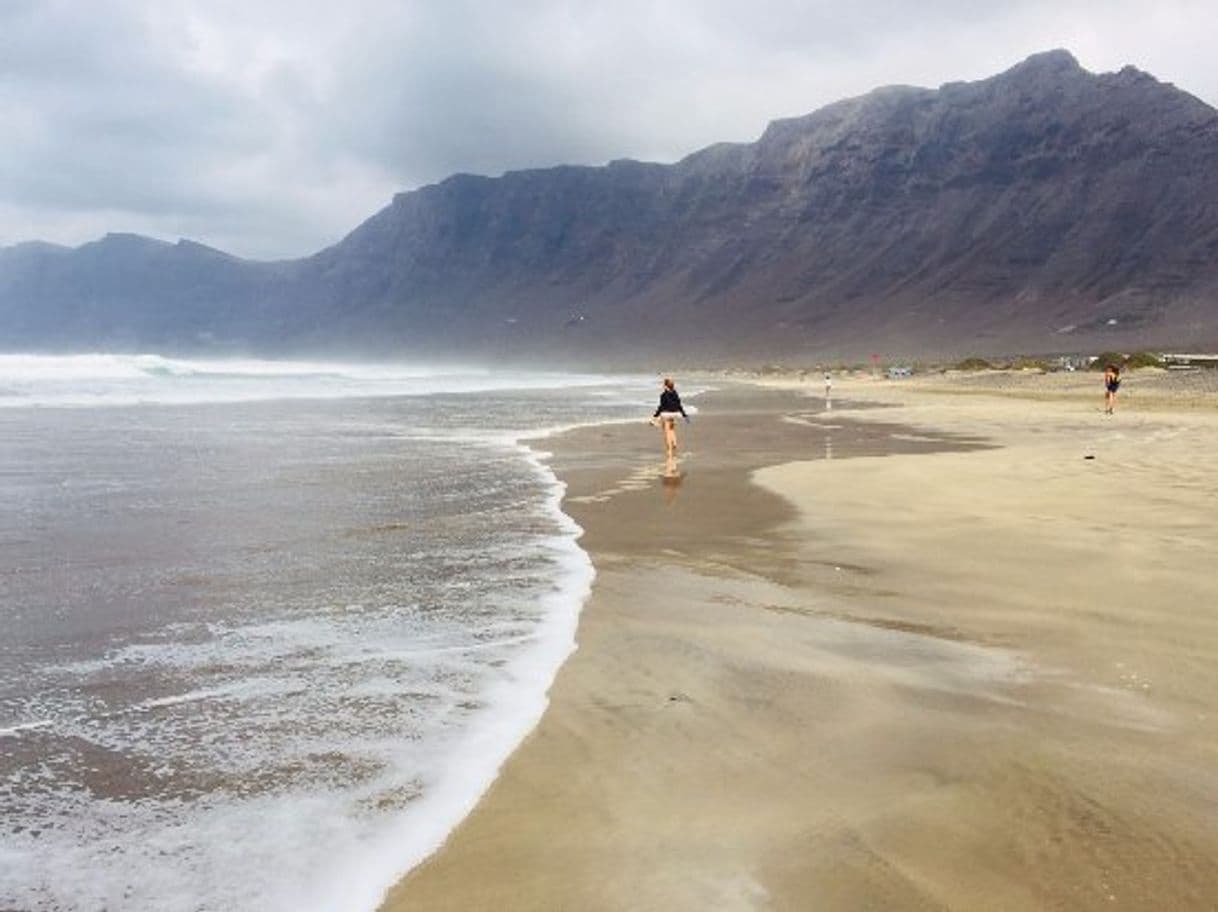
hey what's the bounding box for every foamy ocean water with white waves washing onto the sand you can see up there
[0,354,655,912]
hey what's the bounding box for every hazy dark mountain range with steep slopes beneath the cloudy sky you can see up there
[0,51,1218,363]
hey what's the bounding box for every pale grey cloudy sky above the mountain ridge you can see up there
[0,0,1218,258]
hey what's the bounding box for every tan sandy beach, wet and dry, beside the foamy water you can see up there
[384,371,1218,912]
